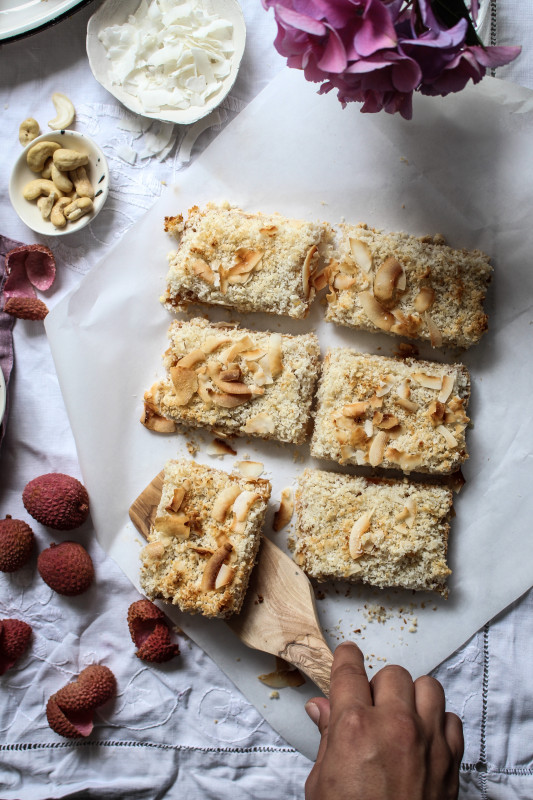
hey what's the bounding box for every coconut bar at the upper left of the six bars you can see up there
[161,203,330,319]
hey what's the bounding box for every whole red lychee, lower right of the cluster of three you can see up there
[37,542,94,597]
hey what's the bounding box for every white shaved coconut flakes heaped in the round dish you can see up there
[98,0,235,114]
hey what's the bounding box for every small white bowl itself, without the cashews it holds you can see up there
[9,131,109,236]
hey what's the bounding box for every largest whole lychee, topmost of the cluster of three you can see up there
[22,472,89,531]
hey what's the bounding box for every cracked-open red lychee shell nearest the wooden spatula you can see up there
[128,599,180,664]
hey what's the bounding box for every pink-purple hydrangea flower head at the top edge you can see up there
[262,0,521,119]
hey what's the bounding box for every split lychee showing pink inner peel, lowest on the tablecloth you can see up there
[46,664,117,739]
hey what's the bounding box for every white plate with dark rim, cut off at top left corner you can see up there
[0,0,91,41]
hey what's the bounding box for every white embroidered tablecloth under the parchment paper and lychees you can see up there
[0,0,533,800]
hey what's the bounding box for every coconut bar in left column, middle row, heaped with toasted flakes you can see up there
[141,319,320,444]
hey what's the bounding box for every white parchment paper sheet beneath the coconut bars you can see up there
[46,70,533,757]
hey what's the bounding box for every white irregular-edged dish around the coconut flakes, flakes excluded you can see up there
[86,0,246,125]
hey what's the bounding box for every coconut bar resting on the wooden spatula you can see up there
[141,459,271,617]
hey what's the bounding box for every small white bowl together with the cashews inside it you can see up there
[9,130,109,236]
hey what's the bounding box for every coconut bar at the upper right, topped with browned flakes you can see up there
[326,224,492,348]
